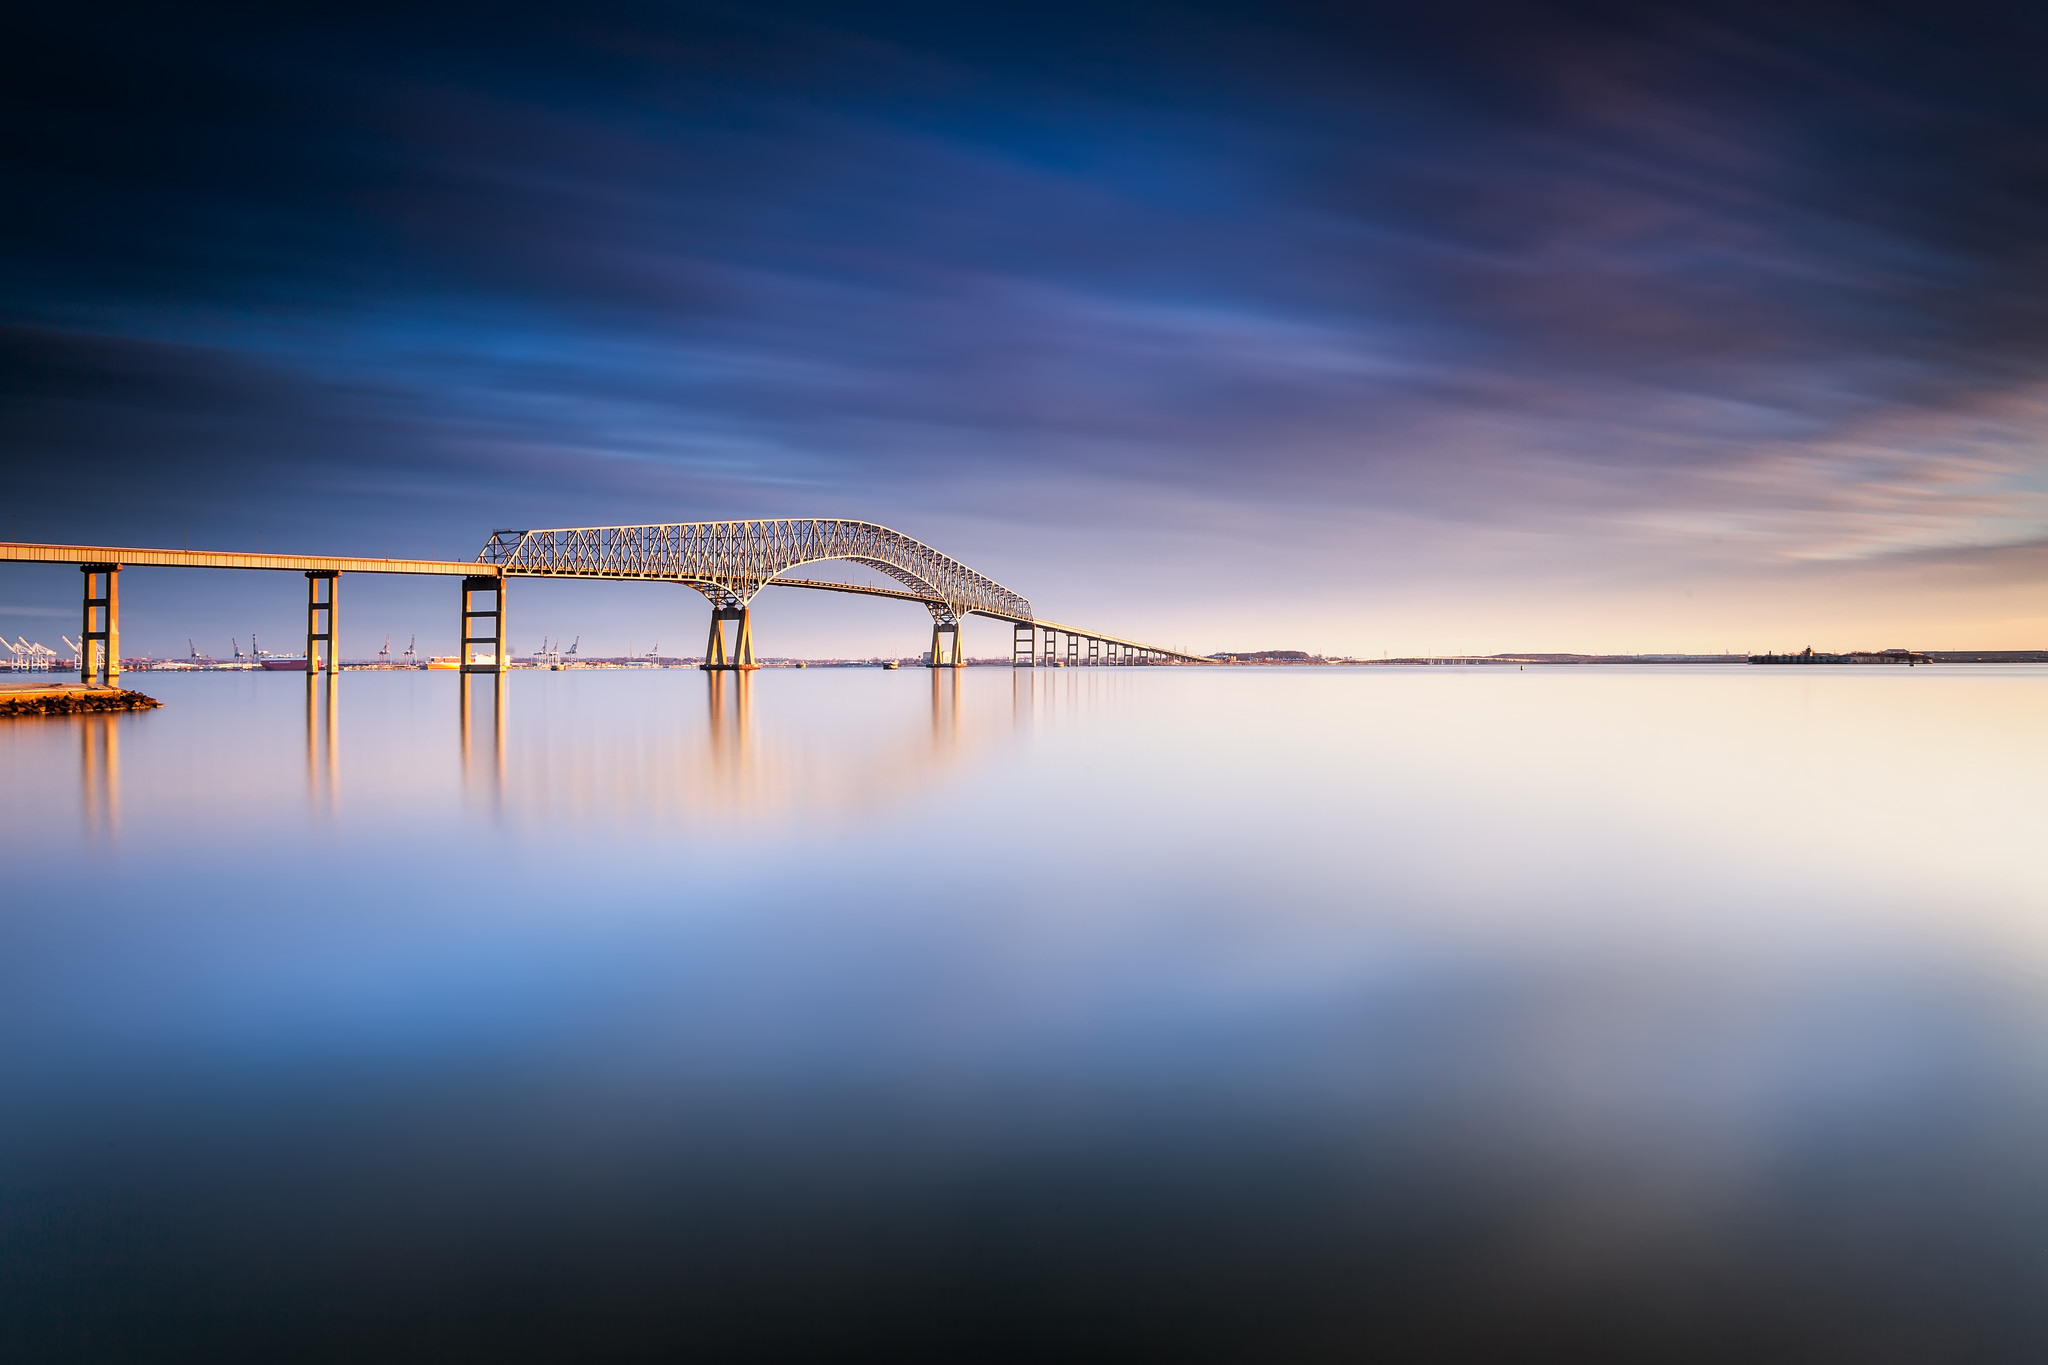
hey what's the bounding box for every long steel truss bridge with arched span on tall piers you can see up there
[0,518,1208,686]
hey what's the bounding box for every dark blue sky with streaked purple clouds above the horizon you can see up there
[0,2,2048,657]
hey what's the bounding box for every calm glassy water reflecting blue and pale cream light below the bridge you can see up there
[0,665,2048,1361]
